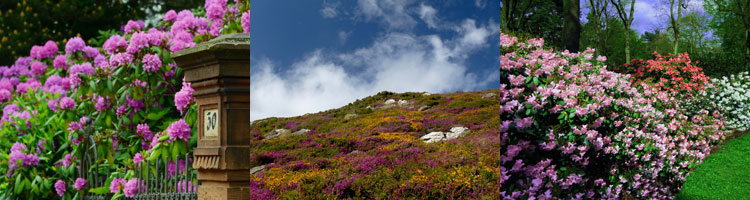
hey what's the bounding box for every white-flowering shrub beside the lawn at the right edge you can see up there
[685,72,750,130]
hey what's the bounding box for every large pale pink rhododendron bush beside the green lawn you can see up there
[500,33,723,199]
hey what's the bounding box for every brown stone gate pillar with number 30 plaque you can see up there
[173,33,251,200]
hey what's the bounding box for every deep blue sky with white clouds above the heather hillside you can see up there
[250,0,500,120]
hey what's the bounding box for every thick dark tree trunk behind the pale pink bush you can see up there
[563,0,581,53]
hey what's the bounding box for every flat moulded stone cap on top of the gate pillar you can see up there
[172,33,250,59]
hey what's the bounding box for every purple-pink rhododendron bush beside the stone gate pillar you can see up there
[0,0,249,199]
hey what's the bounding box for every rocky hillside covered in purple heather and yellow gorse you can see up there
[250,89,500,199]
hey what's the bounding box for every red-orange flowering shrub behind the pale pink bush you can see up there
[615,52,709,97]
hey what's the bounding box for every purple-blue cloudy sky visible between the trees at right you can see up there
[581,0,706,35]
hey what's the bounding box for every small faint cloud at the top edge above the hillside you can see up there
[358,0,417,29]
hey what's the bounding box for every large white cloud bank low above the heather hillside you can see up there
[250,19,499,120]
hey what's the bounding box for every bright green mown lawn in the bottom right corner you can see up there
[677,134,750,200]
